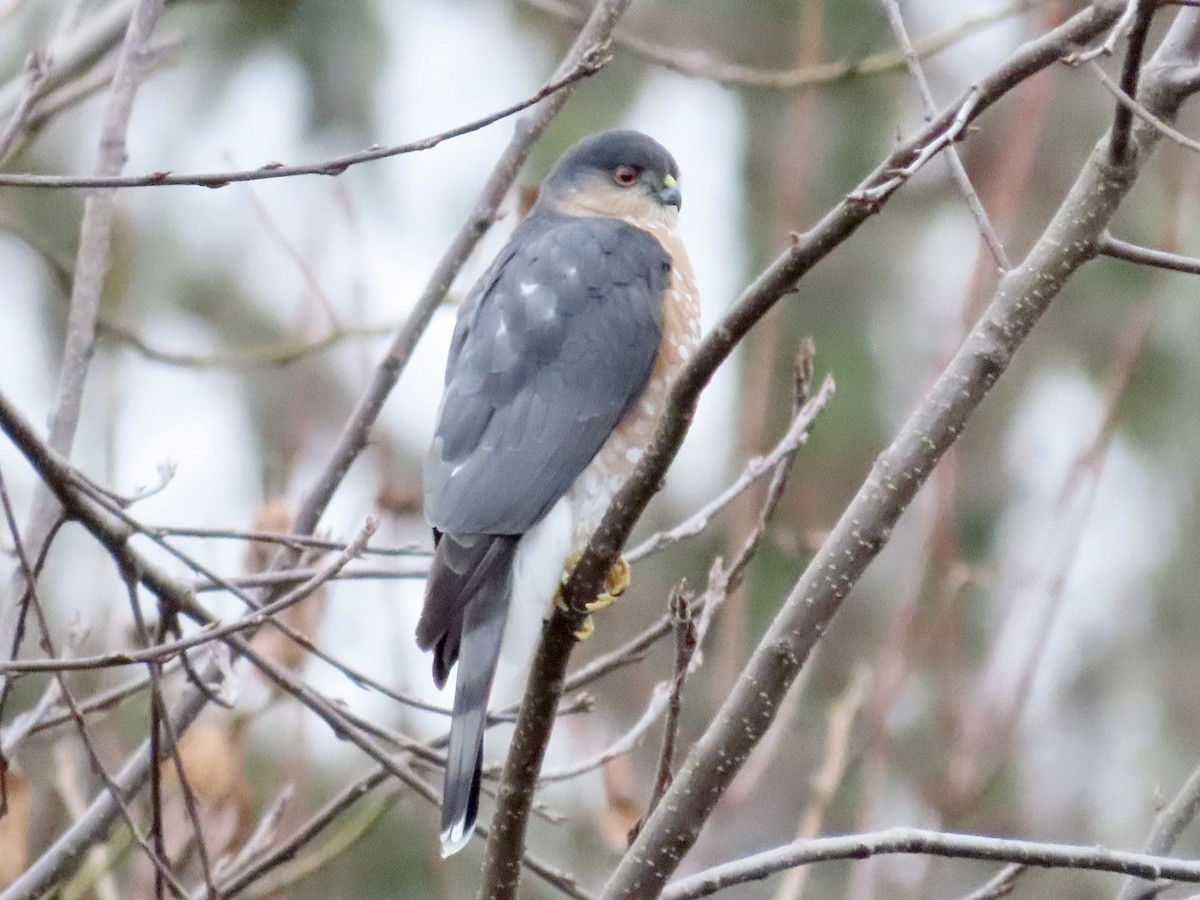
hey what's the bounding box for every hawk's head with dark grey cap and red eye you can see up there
[540,131,683,226]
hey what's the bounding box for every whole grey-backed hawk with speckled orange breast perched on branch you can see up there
[416,131,700,856]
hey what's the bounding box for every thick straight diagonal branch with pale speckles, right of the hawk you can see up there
[604,8,1200,899]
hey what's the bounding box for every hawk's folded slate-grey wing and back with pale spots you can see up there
[425,211,671,534]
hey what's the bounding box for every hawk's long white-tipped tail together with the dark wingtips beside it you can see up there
[418,534,518,857]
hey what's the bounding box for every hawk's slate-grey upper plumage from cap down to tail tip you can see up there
[416,132,677,853]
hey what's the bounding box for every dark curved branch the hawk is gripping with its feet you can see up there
[475,6,1121,898]
